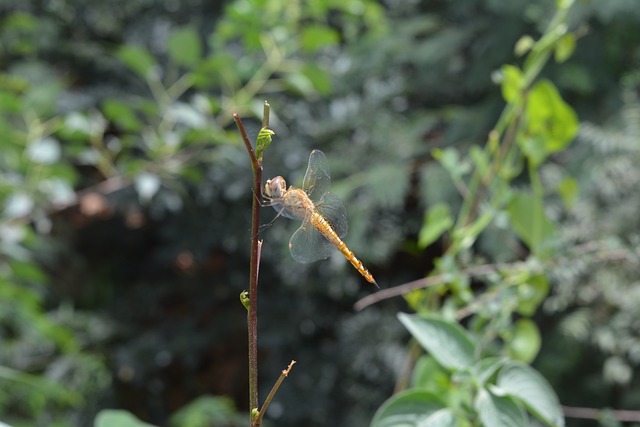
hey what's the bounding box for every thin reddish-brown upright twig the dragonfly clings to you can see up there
[233,113,262,426]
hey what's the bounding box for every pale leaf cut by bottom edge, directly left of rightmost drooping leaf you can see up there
[474,389,527,427]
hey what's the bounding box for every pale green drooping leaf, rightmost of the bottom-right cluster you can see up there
[496,362,564,427]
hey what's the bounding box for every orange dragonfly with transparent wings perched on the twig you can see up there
[264,150,378,287]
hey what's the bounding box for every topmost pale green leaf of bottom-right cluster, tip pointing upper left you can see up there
[398,313,476,370]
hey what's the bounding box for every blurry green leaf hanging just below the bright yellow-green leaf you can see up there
[507,192,555,258]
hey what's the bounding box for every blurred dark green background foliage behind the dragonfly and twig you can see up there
[0,0,640,426]
